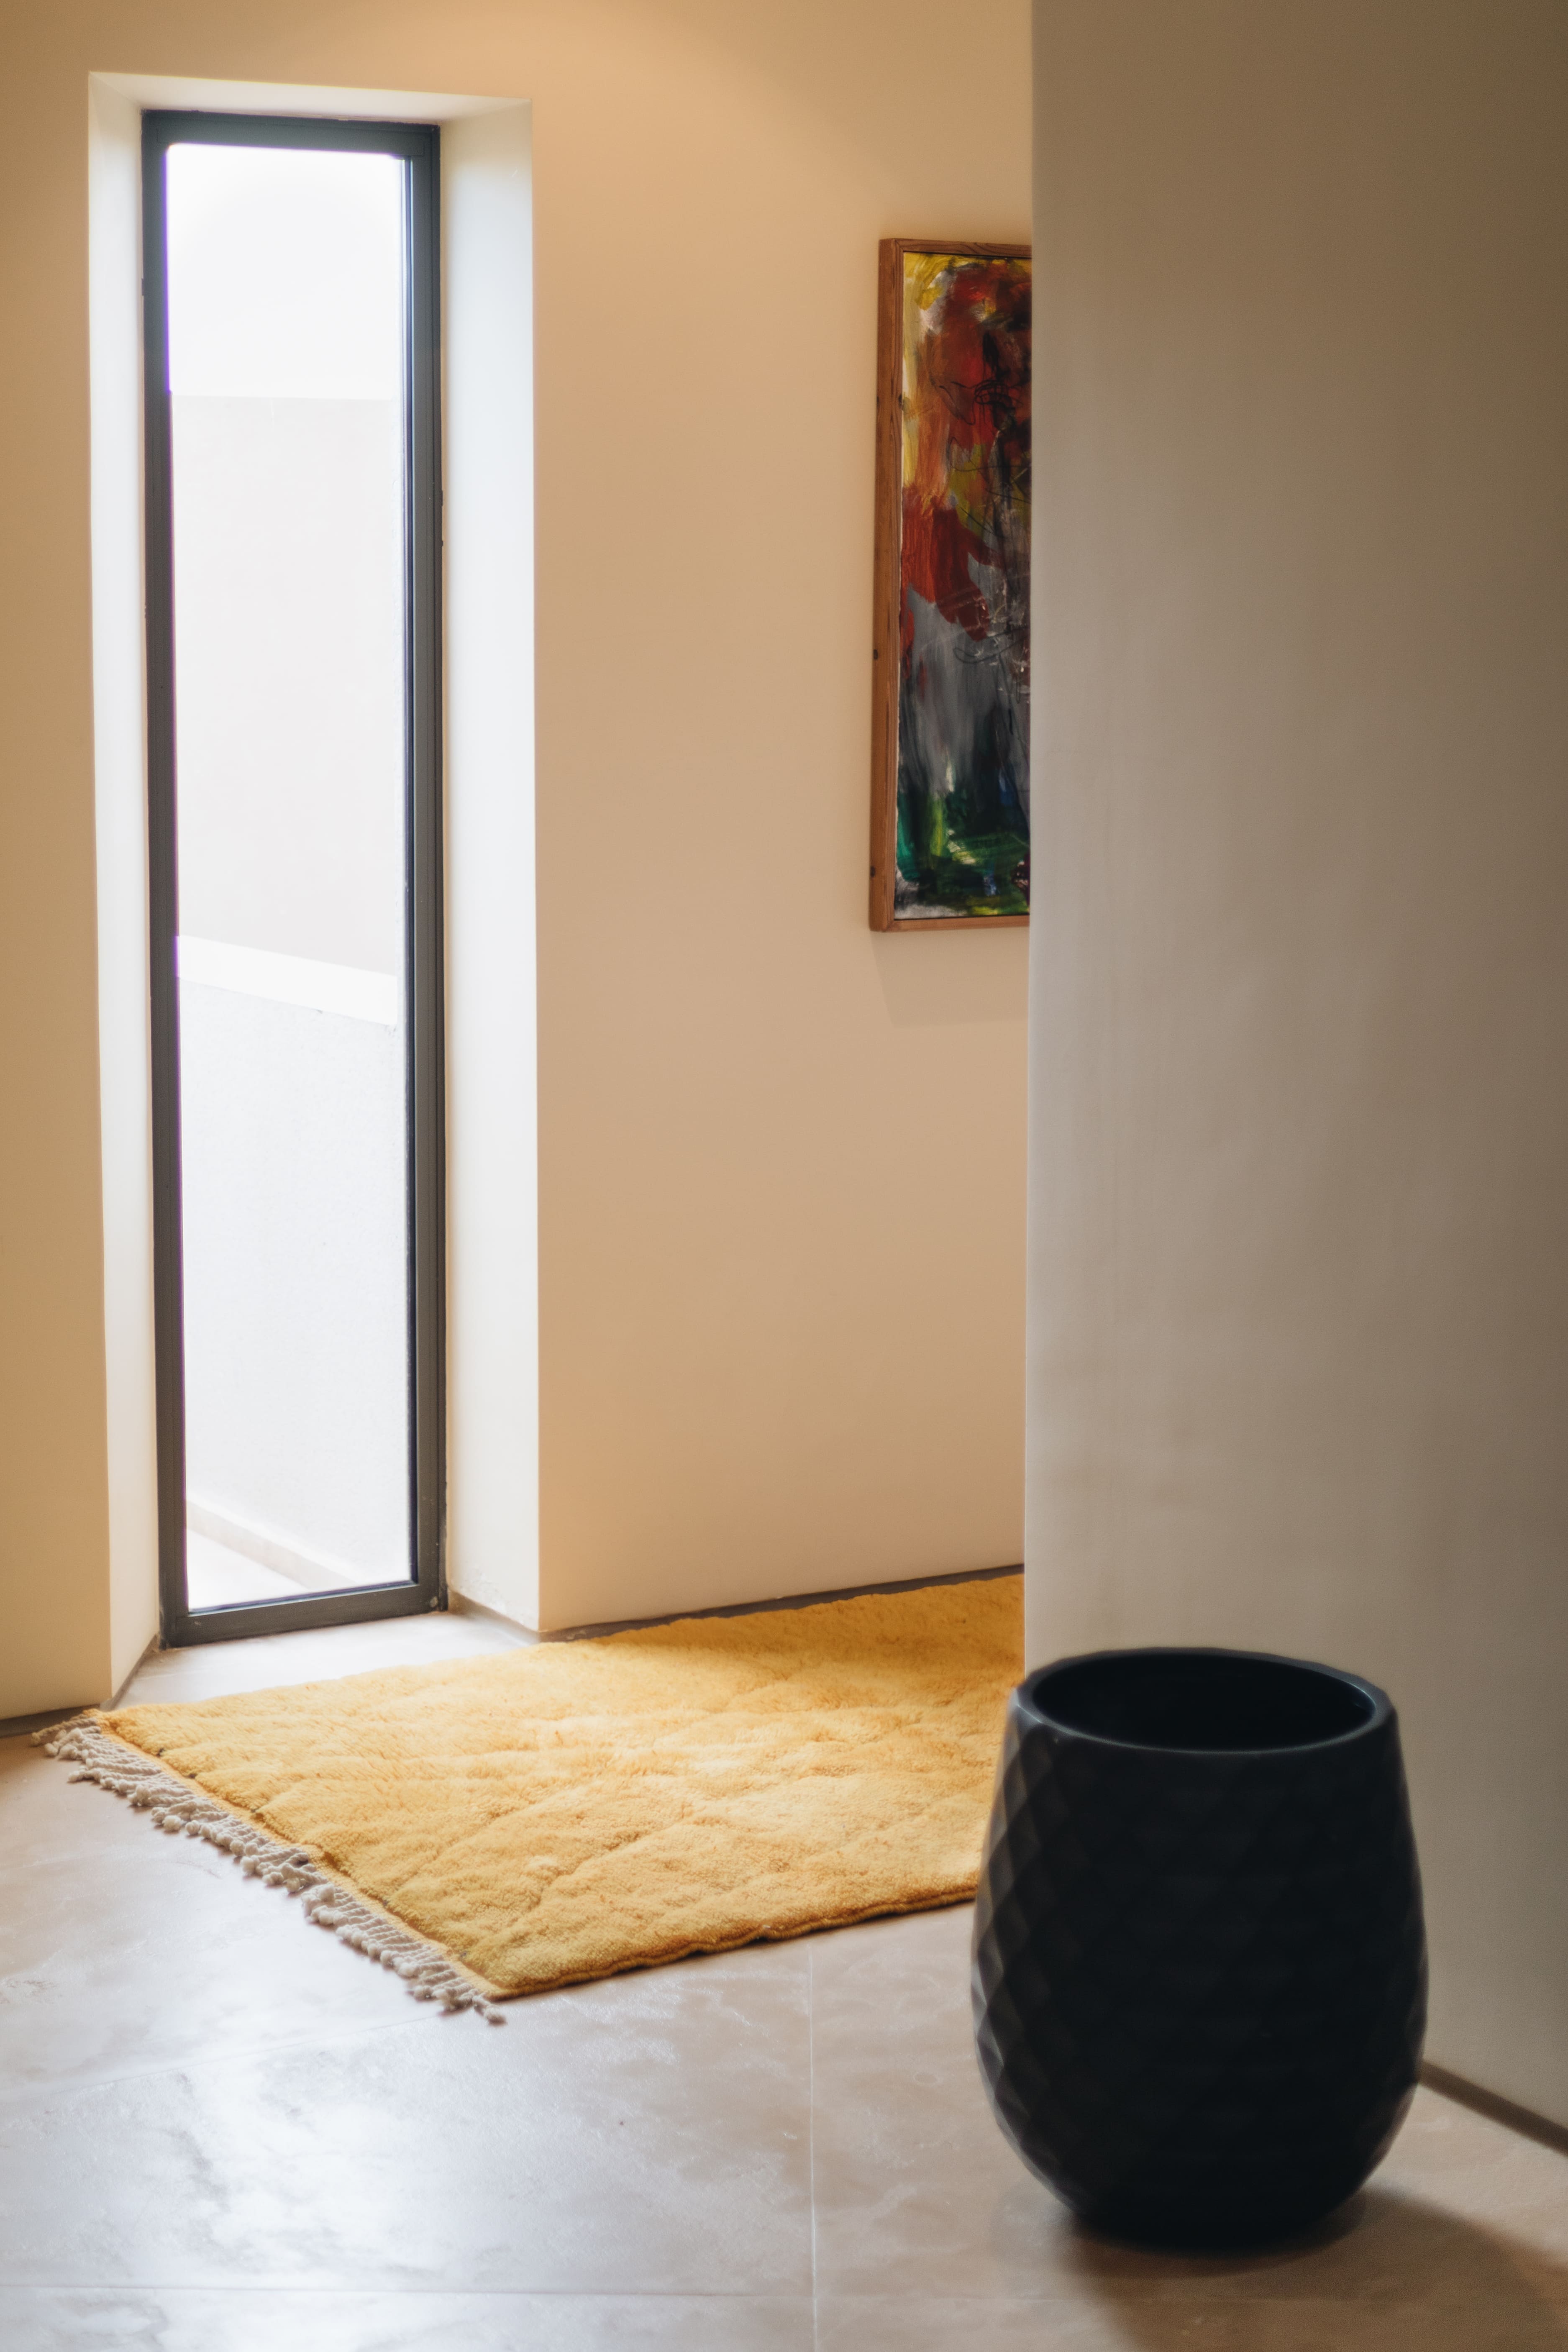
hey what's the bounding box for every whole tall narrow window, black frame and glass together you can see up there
[143,113,442,1642]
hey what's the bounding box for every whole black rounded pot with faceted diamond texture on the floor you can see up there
[973,1649,1427,2249]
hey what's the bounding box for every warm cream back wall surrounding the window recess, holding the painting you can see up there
[0,0,1030,1714]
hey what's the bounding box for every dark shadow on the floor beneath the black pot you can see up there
[1065,2185,1568,2352]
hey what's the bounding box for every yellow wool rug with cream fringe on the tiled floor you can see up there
[42,1576,1022,2013]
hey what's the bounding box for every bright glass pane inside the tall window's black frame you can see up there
[167,146,411,1609]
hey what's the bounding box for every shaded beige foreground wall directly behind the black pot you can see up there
[1027,0,1568,2121]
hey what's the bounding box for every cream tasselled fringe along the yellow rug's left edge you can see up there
[33,1714,505,2025]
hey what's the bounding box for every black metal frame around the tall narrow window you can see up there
[141,110,447,1649]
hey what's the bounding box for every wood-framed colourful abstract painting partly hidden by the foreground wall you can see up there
[870,238,1030,931]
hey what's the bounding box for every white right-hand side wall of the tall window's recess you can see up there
[442,106,538,1625]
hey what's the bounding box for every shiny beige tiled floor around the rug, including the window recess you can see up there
[0,1616,1568,2352]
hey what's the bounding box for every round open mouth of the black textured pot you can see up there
[1025,1649,1385,1755]
